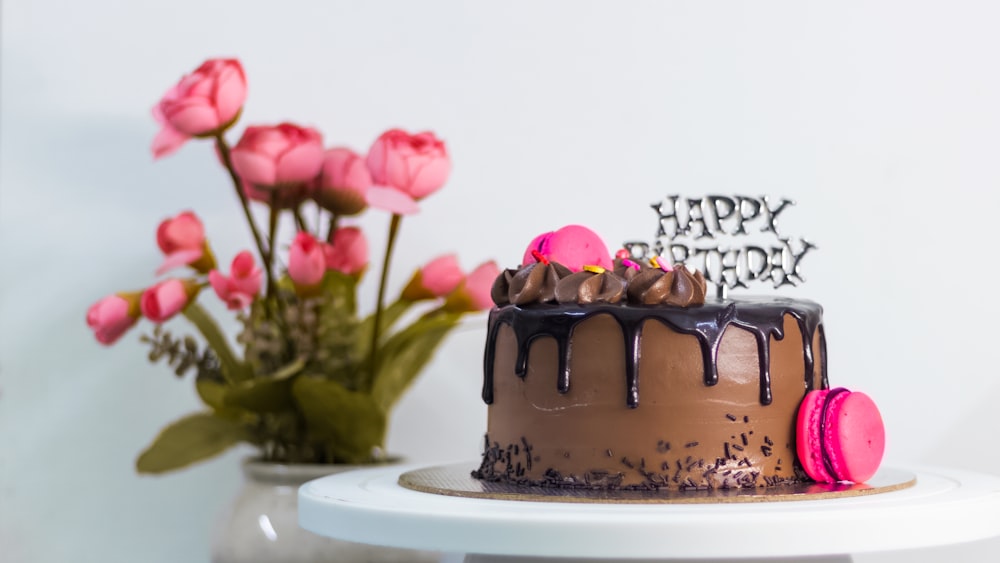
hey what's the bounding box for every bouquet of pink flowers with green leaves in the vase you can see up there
[87,59,498,473]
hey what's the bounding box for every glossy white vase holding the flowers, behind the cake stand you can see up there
[212,460,441,563]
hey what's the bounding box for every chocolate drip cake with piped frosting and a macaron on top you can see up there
[472,226,881,491]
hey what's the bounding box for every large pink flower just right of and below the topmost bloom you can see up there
[231,123,323,197]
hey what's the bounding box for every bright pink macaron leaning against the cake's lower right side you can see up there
[796,387,885,483]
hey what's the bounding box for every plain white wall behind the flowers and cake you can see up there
[0,0,1000,563]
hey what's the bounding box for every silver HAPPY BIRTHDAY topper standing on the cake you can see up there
[624,195,816,298]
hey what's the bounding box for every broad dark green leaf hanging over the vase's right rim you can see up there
[292,375,387,463]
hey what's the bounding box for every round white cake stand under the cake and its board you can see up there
[299,462,1000,562]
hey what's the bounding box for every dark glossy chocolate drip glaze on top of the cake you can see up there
[483,298,828,408]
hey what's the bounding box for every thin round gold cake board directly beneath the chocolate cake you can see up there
[399,464,917,504]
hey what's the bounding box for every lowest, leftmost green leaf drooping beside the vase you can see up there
[135,413,250,473]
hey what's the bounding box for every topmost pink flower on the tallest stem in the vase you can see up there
[152,59,247,158]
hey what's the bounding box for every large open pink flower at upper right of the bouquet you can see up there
[367,129,451,200]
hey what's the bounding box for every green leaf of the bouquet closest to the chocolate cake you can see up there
[372,313,462,412]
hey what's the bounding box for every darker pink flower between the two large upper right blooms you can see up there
[313,148,372,215]
